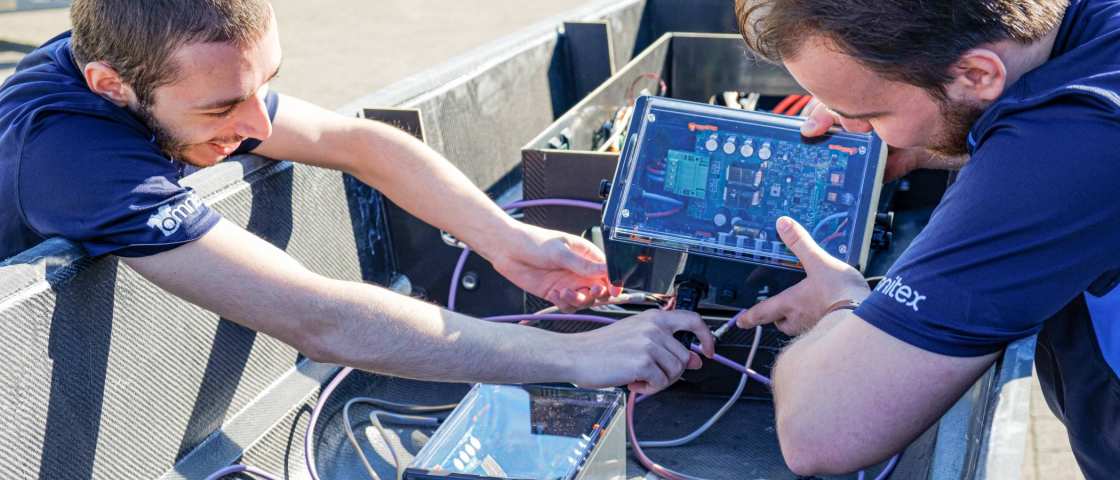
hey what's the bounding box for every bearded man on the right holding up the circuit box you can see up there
[736,0,1120,479]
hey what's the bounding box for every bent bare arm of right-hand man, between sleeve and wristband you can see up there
[773,311,995,474]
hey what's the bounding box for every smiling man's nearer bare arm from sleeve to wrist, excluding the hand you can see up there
[125,220,578,383]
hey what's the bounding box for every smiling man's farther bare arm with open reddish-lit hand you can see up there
[254,96,610,310]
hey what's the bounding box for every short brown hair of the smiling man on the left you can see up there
[71,0,272,105]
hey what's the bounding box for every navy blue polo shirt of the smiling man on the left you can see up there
[0,32,278,260]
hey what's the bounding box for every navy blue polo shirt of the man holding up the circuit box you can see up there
[856,0,1120,478]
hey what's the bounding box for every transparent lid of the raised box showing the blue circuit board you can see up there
[604,96,886,269]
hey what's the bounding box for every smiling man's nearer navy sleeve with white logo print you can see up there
[18,114,221,256]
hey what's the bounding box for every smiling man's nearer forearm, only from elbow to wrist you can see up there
[308,276,576,383]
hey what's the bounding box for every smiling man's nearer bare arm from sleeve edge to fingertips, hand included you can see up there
[123,220,712,392]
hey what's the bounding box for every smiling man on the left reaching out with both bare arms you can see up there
[0,0,713,392]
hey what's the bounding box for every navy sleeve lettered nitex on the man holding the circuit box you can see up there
[856,97,1120,356]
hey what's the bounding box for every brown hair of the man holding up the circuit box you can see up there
[735,0,1068,98]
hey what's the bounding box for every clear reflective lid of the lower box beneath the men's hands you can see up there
[409,384,623,479]
